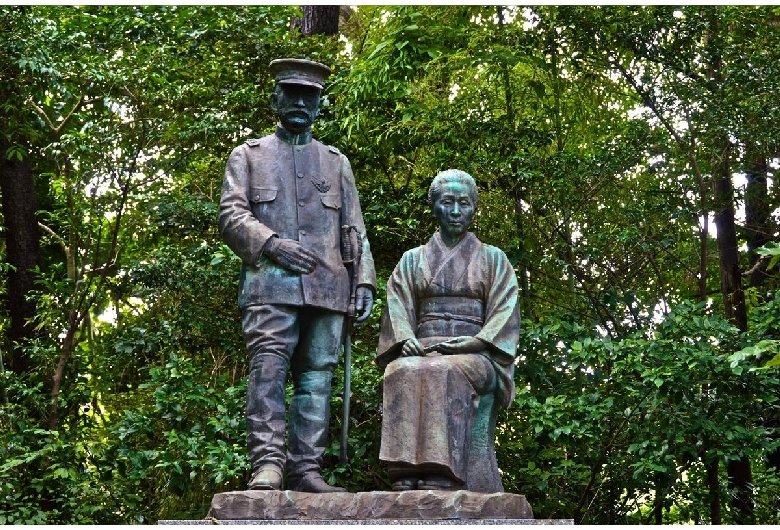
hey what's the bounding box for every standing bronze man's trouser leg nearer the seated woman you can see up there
[287,309,344,489]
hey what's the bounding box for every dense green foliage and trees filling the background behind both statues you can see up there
[0,6,780,524]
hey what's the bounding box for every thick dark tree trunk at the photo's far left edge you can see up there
[0,88,41,374]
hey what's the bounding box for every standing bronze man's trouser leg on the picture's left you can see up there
[242,305,298,474]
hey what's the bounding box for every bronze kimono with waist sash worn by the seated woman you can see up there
[376,232,520,483]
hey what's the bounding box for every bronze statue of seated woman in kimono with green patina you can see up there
[377,170,520,493]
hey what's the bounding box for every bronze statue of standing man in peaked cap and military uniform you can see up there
[219,59,376,493]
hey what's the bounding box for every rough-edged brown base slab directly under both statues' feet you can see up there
[207,490,534,523]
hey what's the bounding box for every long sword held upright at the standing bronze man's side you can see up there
[339,225,363,464]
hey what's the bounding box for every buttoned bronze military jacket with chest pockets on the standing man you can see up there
[219,127,376,312]
